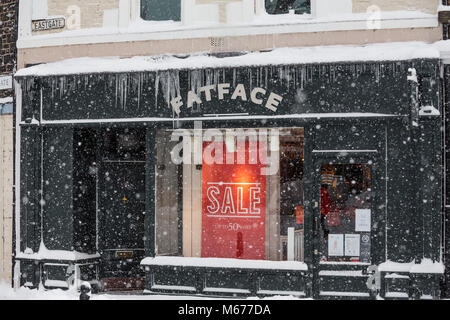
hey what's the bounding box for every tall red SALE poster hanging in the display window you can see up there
[202,142,266,260]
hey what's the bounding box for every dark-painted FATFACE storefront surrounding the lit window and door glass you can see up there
[15,59,443,299]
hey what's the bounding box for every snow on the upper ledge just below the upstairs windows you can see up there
[17,11,439,49]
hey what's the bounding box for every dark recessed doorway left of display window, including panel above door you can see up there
[98,129,145,291]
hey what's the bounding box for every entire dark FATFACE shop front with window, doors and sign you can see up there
[16,54,442,299]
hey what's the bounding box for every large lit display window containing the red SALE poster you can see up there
[155,128,304,261]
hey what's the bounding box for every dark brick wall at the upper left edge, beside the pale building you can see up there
[0,0,18,98]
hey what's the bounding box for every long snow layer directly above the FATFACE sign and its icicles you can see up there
[15,42,439,77]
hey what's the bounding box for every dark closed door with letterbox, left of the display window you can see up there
[99,161,145,290]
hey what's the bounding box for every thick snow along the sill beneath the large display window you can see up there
[141,256,308,271]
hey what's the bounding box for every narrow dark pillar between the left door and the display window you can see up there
[144,124,156,257]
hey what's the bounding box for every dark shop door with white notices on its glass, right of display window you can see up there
[313,153,385,296]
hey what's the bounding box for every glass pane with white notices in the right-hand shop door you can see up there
[320,164,372,263]
